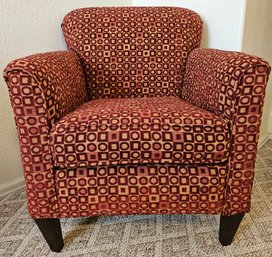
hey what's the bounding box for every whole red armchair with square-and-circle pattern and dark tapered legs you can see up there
[4,7,270,251]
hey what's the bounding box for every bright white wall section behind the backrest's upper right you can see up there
[133,0,245,51]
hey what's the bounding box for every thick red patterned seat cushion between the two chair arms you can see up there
[50,97,230,168]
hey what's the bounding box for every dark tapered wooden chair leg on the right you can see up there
[219,213,245,246]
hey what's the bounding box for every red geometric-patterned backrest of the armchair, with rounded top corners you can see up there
[62,7,202,99]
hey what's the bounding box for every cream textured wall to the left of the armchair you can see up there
[0,0,132,195]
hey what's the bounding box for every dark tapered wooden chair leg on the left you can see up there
[34,219,64,253]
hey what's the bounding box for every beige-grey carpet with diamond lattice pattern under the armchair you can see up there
[0,141,272,257]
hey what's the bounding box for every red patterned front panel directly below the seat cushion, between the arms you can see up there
[55,165,227,217]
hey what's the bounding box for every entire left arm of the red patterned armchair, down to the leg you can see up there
[4,51,87,218]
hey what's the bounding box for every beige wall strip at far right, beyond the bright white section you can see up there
[242,0,272,145]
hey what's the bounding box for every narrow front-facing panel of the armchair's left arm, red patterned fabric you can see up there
[5,70,59,218]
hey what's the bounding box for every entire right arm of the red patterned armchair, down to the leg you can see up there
[181,49,270,215]
